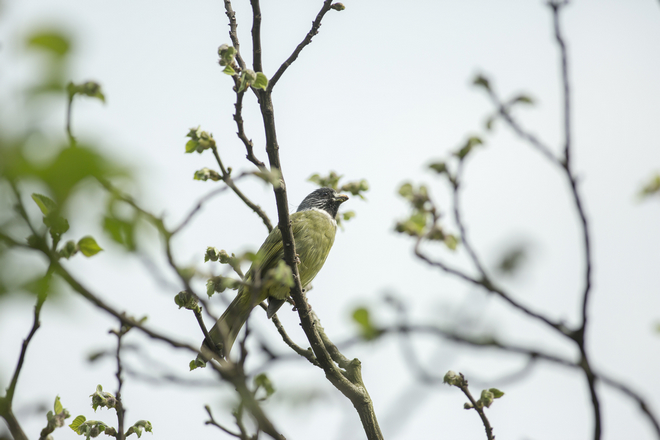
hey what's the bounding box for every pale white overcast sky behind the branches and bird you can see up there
[0,0,660,439]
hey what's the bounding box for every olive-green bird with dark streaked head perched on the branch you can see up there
[202,188,348,357]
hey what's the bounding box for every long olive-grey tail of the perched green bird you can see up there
[201,289,256,358]
